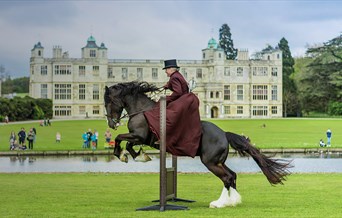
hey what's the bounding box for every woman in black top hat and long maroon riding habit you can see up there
[144,59,202,157]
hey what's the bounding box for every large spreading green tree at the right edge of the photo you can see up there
[296,36,342,115]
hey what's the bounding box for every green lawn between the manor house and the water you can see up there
[0,119,342,151]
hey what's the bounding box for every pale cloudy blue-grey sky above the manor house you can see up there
[0,0,342,78]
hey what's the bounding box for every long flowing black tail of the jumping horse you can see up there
[226,132,292,184]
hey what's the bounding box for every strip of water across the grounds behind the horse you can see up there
[0,153,342,173]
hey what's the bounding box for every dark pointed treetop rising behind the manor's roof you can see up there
[219,24,237,60]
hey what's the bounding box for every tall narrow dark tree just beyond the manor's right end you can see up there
[278,37,300,117]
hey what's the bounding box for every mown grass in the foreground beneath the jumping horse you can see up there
[0,173,342,218]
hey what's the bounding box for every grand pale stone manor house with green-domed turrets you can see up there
[30,36,282,118]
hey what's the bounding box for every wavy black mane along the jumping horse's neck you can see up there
[105,81,159,98]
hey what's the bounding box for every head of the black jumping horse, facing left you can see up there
[104,86,124,130]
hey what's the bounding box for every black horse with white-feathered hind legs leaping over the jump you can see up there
[104,82,291,208]
